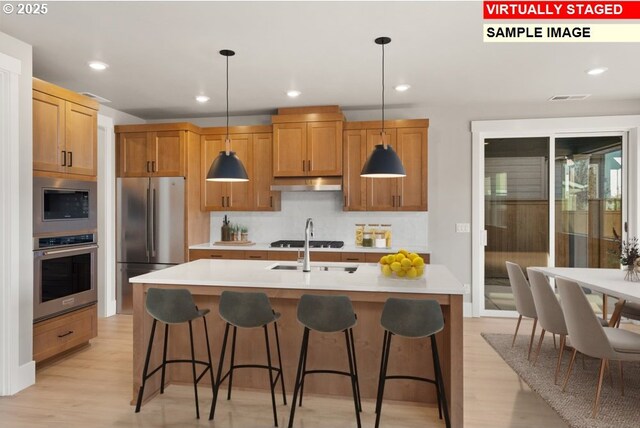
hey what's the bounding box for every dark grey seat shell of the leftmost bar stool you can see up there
[145,288,202,324]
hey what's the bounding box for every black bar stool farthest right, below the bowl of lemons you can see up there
[375,297,453,428]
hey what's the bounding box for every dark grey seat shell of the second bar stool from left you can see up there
[219,291,275,328]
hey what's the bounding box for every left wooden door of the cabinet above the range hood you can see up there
[273,122,308,177]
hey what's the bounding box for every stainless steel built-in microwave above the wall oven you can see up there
[33,177,98,236]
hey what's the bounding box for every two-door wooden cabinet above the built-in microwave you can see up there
[33,79,98,178]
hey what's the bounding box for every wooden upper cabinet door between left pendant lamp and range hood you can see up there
[249,133,280,211]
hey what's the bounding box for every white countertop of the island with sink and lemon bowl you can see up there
[129,259,464,295]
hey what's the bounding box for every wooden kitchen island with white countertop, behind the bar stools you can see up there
[131,260,464,427]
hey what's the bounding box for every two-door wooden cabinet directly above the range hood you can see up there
[272,113,344,177]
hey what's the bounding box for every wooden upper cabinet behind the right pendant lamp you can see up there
[343,119,429,211]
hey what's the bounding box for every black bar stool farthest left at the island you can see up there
[136,288,215,418]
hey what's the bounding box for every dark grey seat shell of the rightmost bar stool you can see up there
[380,297,444,337]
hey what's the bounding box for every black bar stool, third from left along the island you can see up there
[289,294,362,428]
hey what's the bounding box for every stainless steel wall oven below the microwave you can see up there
[33,233,98,321]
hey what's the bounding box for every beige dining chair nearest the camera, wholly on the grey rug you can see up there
[556,278,640,418]
